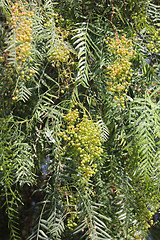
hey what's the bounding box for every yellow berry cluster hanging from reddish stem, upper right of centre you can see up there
[104,36,136,108]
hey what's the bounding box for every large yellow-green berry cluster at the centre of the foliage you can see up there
[60,109,103,181]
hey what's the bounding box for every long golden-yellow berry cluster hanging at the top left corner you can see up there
[9,1,35,80]
